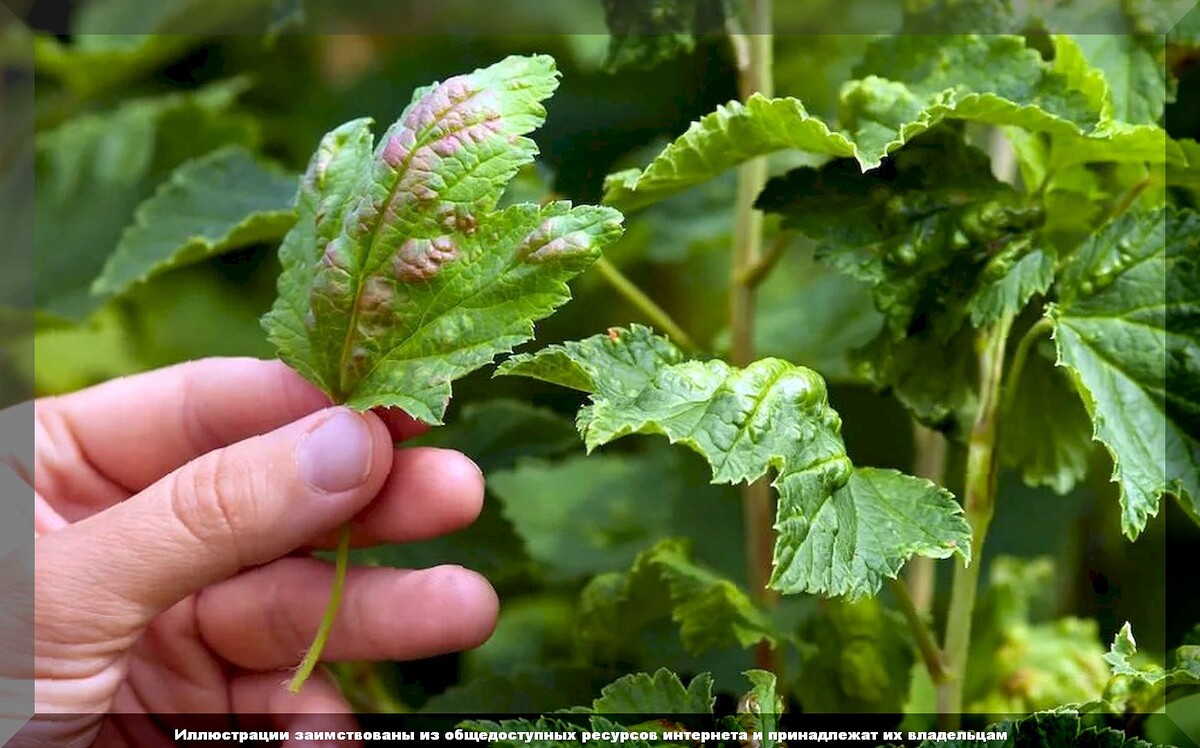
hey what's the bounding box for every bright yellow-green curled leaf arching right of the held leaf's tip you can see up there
[605,94,856,211]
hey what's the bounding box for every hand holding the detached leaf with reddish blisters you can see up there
[18,359,498,746]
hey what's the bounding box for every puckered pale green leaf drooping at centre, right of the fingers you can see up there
[498,325,970,598]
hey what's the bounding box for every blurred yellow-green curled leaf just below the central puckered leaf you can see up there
[578,539,775,659]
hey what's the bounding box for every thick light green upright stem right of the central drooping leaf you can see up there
[937,315,1013,729]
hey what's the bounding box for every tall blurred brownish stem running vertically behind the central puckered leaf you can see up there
[730,0,781,676]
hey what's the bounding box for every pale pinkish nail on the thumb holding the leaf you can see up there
[296,409,372,493]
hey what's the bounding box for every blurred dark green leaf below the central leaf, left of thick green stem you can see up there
[796,599,916,714]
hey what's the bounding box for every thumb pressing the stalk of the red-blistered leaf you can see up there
[35,408,392,641]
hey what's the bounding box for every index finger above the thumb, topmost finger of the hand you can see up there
[35,358,420,502]
